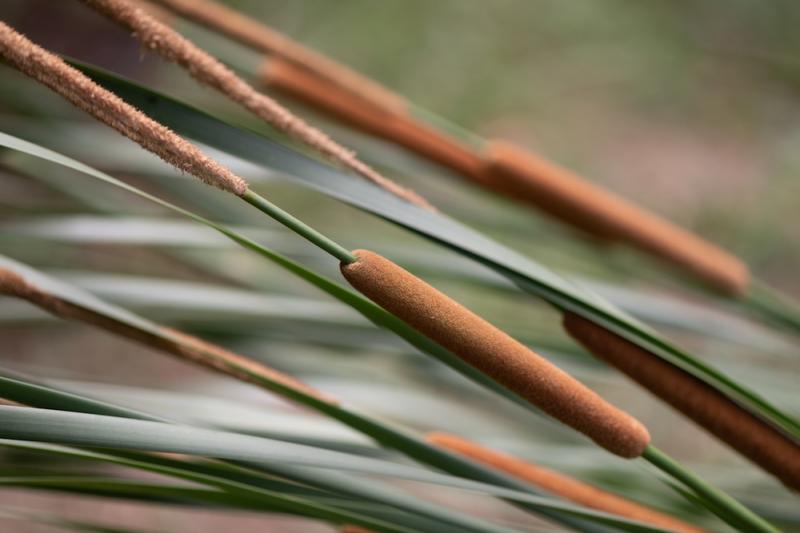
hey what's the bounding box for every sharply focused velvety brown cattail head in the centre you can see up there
[341,250,650,458]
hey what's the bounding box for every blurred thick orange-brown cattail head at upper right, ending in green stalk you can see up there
[485,141,749,294]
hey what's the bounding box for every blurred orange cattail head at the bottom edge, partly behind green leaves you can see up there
[426,432,703,533]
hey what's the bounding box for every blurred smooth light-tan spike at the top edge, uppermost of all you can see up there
[145,0,406,114]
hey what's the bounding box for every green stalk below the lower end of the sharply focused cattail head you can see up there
[642,444,779,533]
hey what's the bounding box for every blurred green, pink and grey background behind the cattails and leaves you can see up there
[0,0,800,532]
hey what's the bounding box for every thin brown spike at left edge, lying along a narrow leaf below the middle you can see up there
[0,268,337,404]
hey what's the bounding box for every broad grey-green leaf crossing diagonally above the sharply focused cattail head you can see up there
[65,62,800,437]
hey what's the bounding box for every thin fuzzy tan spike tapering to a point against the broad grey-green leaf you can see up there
[83,0,432,210]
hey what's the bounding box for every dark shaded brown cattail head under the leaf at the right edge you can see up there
[564,313,800,491]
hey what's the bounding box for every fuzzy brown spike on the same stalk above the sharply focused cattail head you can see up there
[0,21,247,196]
